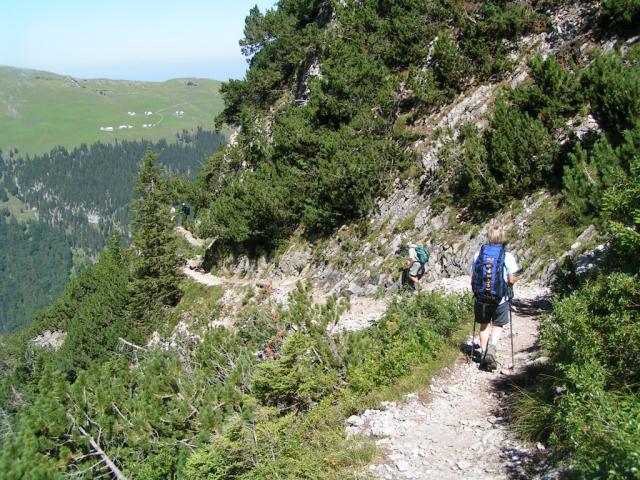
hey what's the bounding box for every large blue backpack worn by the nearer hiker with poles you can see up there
[471,243,507,305]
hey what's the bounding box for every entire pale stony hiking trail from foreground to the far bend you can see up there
[178,228,553,480]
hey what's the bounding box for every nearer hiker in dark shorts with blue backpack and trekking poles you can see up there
[471,227,520,371]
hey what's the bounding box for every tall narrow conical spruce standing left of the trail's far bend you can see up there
[129,151,180,332]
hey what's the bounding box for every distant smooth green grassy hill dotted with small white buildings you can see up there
[0,66,222,154]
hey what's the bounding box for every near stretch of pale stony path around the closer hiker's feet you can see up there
[347,285,548,480]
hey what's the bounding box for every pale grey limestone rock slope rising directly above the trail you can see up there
[194,0,608,325]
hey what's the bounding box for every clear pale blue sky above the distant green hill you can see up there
[0,0,276,80]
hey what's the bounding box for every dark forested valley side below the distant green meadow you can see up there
[0,129,224,332]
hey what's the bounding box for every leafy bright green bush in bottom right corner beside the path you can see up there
[516,274,640,479]
